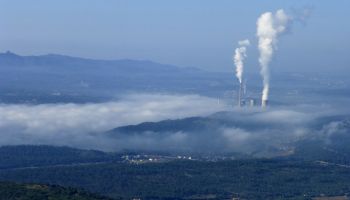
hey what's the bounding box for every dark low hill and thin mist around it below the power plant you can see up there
[110,105,348,157]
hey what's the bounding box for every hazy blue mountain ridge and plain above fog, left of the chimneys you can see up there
[0,51,231,104]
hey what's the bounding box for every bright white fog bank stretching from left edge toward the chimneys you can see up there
[0,94,224,149]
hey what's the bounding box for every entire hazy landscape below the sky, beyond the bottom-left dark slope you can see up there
[0,52,350,199]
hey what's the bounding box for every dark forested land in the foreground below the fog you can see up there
[0,143,350,200]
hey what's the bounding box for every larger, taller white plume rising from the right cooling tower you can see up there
[257,9,292,101]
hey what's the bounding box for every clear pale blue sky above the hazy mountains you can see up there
[0,0,350,71]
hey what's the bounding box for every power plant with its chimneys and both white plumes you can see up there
[233,9,293,108]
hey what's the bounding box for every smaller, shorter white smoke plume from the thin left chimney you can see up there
[233,40,250,83]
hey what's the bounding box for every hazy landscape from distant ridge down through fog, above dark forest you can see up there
[0,52,350,154]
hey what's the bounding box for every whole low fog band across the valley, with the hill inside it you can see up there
[0,94,347,153]
